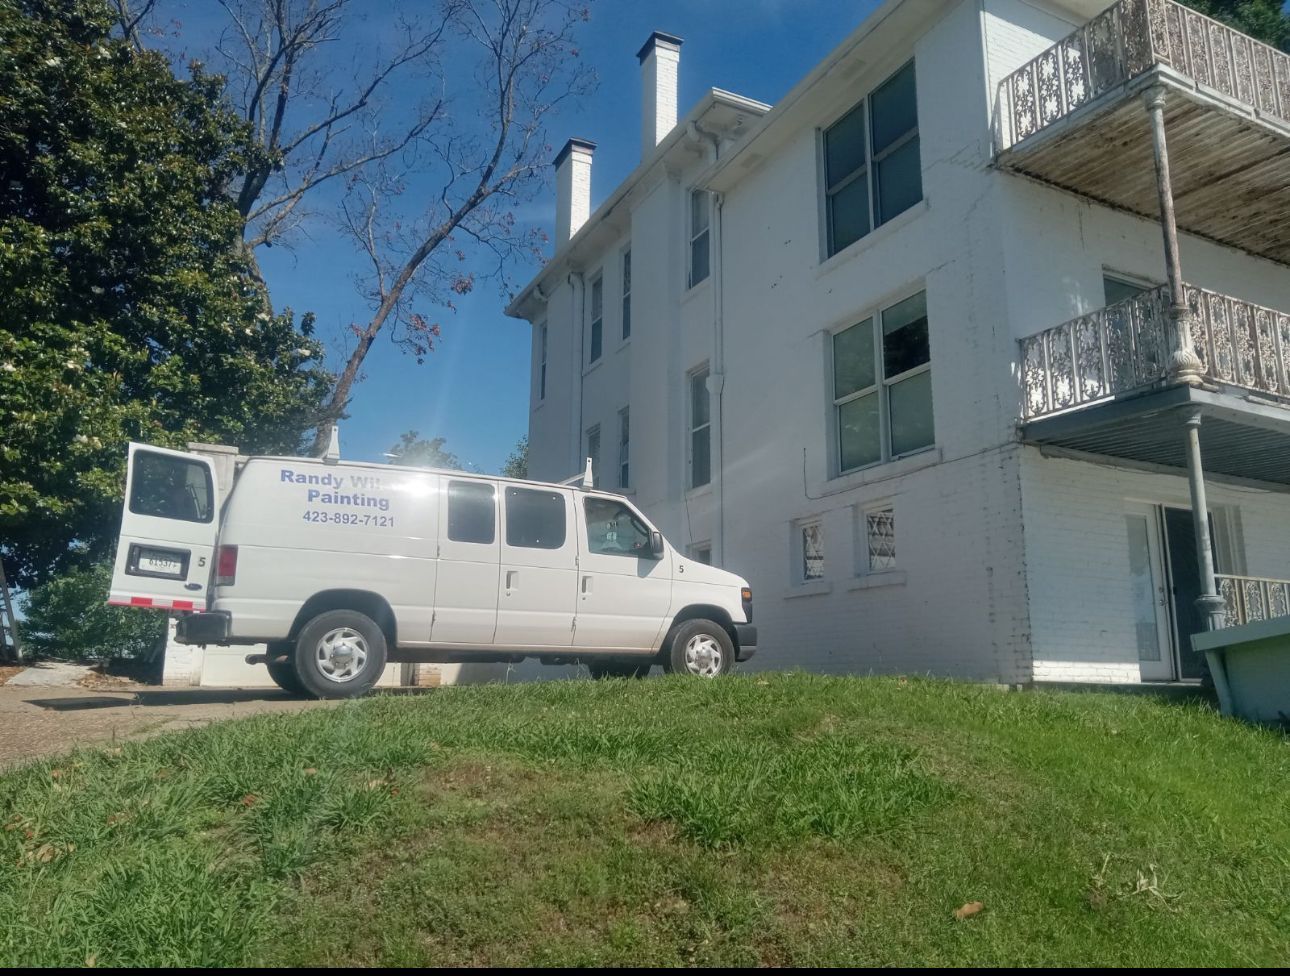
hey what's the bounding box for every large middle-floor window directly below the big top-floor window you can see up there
[833,291,935,473]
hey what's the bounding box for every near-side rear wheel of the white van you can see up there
[295,610,386,698]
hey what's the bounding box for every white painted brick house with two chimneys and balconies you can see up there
[508,0,1290,682]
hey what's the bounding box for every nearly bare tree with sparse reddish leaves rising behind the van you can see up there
[114,0,591,454]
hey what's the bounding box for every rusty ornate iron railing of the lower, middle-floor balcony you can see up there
[1020,285,1290,420]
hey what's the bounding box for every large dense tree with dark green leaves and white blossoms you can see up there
[0,0,330,588]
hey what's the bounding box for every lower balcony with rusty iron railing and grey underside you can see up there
[1019,285,1290,485]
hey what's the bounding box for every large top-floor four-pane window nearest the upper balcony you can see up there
[824,61,922,257]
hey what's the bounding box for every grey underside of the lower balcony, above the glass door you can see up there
[1022,387,1290,485]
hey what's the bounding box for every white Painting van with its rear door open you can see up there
[108,444,757,698]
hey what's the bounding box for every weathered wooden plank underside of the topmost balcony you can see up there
[998,67,1290,264]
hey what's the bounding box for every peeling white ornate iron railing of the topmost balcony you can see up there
[997,0,1290,151]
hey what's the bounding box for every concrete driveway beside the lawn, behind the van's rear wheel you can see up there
[0,679,335,770]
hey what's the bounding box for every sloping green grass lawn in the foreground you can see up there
[0,674,1290,966]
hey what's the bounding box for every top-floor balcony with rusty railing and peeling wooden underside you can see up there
[996,0,1290,264]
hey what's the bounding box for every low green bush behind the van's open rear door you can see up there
[22,561,166,660]
